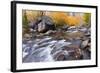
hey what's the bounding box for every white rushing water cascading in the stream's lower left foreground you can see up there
[23,37,71,62]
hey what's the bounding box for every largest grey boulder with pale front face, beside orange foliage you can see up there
[37,16,55,32]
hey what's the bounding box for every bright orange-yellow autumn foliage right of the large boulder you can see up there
[48,12,82,26]
